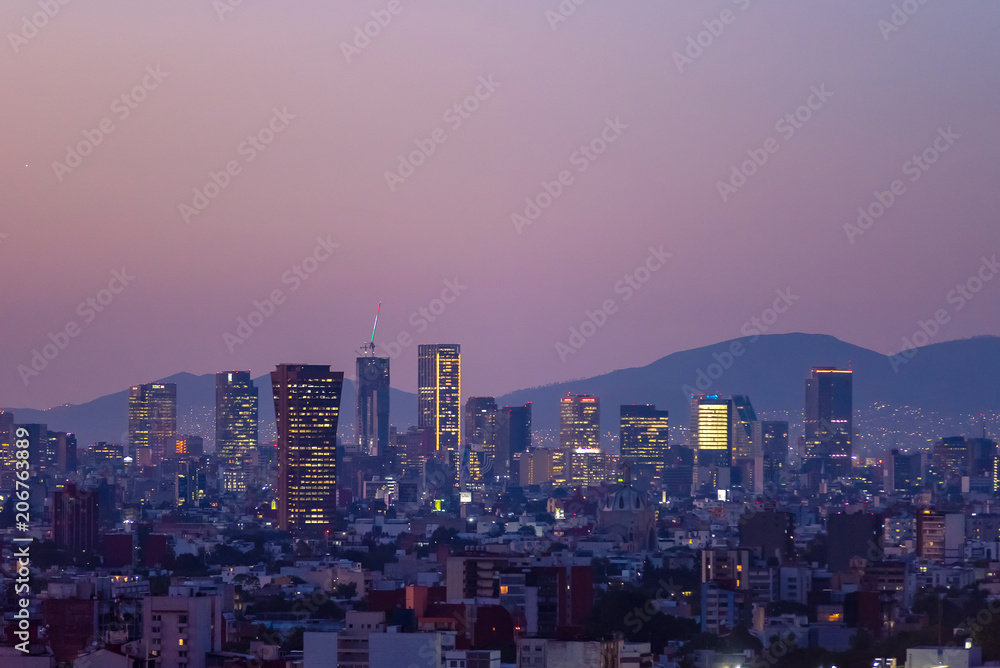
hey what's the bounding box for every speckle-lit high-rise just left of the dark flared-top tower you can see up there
[215,371,258,494]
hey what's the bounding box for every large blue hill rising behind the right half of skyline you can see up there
[497,334,1000,430]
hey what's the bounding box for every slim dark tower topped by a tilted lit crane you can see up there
[354,302,389,456]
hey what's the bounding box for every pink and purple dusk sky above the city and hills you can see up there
[0,0,1000,408]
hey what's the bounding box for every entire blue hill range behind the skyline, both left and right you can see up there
[8,334,1000,444]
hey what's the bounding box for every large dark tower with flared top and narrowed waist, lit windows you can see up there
[271,364,344,531]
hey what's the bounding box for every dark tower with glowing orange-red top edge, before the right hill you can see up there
[803,367,854,477]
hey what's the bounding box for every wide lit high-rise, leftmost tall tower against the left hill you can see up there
[128,383,177,464]
